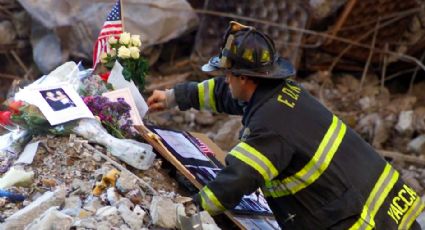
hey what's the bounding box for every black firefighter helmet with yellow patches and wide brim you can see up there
[202,21,295,79]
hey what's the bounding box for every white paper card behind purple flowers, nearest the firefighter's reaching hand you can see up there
[102,88,143,125]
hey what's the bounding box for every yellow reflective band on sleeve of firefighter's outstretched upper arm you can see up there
[198,79,217,112]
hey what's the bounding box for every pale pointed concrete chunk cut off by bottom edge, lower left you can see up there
[25,207,73,230]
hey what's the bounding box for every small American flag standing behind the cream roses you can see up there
[93,0,123,68]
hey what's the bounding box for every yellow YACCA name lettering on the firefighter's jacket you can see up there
[387,185,418,224]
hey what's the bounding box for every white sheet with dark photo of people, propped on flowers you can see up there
[29,83,94,125]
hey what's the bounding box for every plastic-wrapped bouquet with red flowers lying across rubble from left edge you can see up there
[0,101,155,170]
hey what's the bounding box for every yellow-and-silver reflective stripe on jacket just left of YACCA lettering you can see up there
[350,163,399,230]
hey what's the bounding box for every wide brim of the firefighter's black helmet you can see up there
[201,55,296,79]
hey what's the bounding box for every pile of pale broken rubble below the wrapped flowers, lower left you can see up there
[0,135,217,229]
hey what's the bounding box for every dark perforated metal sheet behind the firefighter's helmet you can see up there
[192,0,309,69]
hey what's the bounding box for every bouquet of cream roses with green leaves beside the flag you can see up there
[100,32,149,91]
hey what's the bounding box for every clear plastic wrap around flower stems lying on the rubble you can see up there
[72,118,155,170]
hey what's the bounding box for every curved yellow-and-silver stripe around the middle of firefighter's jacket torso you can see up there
[265,115,347,197]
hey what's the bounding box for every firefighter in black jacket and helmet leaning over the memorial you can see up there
[147,22,424,230]
